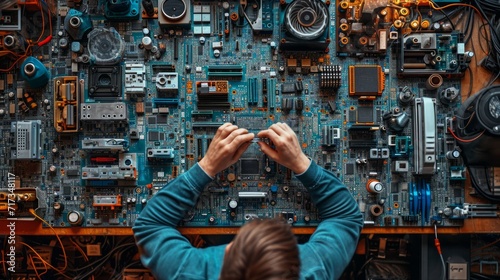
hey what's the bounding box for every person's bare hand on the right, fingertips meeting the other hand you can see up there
[257,123,311,174]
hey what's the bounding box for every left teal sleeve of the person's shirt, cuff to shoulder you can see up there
[132,164,224,279]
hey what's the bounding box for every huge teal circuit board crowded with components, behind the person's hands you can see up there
[0,0,473,227]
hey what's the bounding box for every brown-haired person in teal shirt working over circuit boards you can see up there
[133,123,363,280]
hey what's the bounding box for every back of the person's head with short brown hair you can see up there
[219,219,300,280]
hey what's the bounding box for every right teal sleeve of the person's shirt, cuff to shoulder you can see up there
[297,162,363,279]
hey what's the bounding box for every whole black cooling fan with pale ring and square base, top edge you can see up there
[280,0,330,51]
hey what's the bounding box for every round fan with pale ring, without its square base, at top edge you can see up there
[285,0,330,41]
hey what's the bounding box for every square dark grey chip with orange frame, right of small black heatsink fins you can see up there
[349,65,385,100]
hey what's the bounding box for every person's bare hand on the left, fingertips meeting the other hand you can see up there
[198,123,255,177]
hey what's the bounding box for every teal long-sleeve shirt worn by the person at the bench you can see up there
[133,162,363,280]
